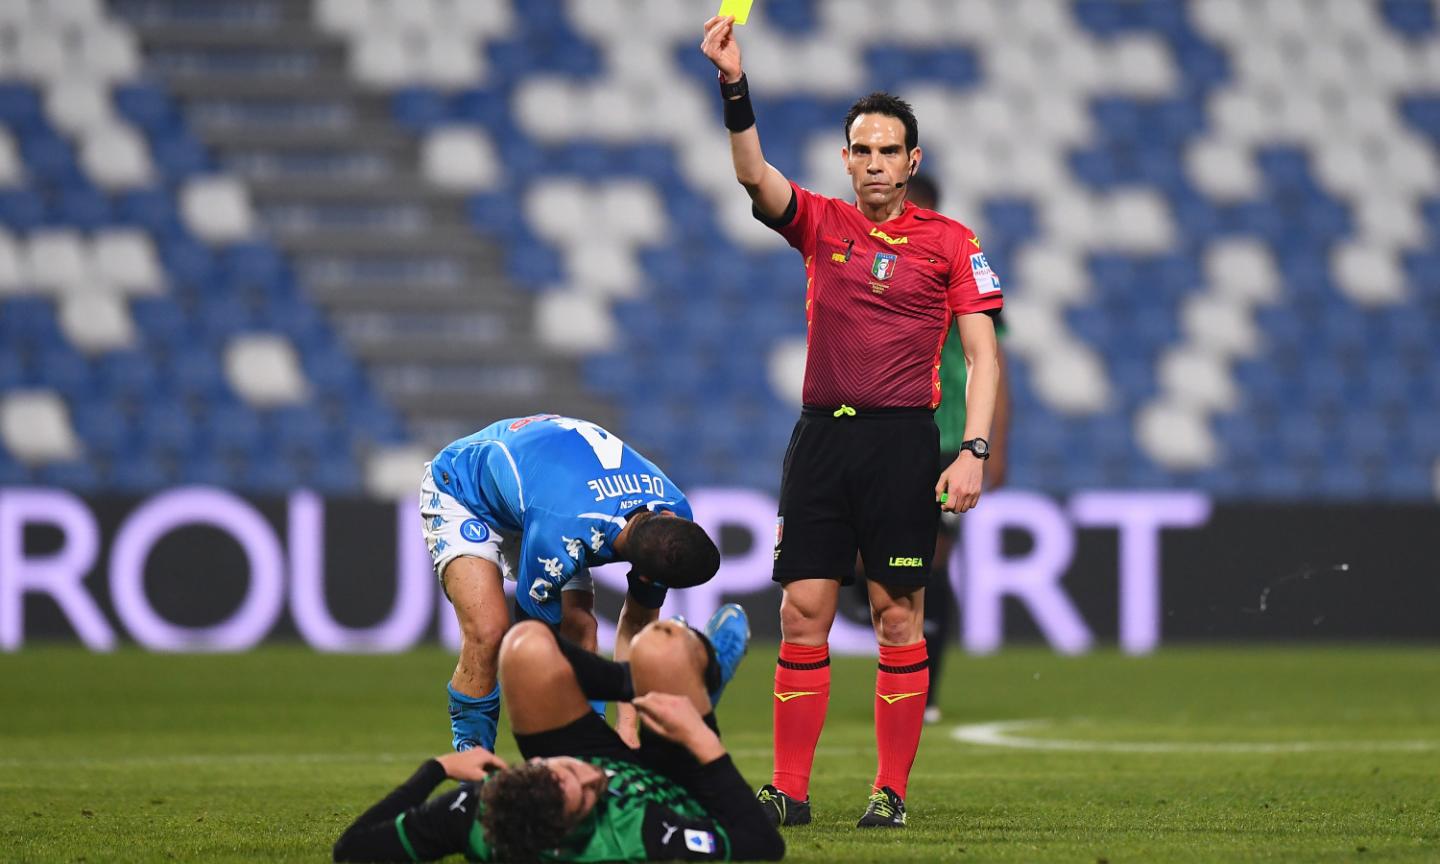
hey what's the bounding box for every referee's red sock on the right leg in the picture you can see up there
[869,641,930,798]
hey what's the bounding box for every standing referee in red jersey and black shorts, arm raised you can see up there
[701,16,1001,828]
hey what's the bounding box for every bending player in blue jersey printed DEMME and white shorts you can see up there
[420,415,720,750]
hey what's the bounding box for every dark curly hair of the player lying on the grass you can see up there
[480,762,570,864]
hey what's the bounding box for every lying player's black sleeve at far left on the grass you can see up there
[334,759,480,861]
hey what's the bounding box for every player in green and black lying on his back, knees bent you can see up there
[334,603,785,861]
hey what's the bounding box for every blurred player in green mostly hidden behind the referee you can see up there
[855,174,1009,723]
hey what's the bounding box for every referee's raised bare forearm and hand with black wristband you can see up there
[700,16,792,219]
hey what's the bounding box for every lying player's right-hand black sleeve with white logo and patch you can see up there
[644,755,785,861]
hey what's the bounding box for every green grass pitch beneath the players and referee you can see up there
[0,645,1440,864]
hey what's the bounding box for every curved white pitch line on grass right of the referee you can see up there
[950,720,1440,753]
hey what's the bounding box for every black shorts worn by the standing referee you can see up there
[775,406,940,588]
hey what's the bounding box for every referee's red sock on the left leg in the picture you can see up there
[770,642,829,801]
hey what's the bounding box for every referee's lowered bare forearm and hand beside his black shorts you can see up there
[935,312,999,513]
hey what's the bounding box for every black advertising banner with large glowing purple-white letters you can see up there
[0,487,1440,654]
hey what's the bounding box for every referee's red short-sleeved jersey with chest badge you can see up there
[756,183,1002,409]
